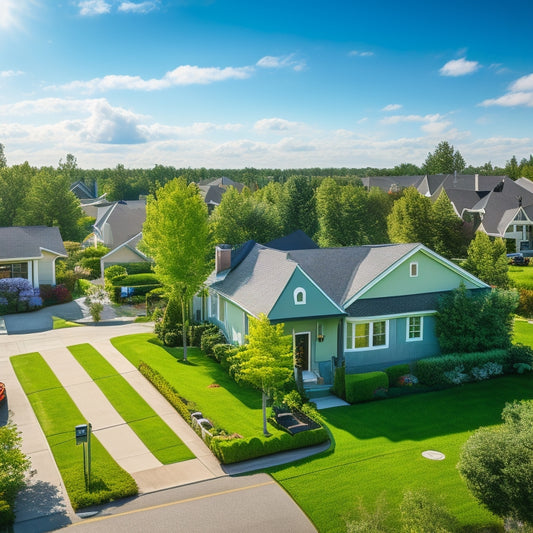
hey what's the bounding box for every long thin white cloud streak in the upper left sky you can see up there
[48,65,252,93]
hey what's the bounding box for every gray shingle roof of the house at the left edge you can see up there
[0,226,67,260]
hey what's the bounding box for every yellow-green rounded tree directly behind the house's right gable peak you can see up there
[387,187,433,247]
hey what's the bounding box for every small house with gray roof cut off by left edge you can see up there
[0,226,67,288]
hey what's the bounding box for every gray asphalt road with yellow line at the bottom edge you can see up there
[62,474,316,533]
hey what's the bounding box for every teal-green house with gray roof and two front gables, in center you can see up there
[203,236,489,383]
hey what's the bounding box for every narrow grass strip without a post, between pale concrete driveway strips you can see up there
[69,344,194,464]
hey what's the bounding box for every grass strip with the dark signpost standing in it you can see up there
[11,353,137,509]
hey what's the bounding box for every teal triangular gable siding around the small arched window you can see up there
[268,267,341,321]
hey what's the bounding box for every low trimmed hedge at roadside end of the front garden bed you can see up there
[211,428,329,464]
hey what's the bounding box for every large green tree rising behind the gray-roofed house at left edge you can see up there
[15,170,83,241]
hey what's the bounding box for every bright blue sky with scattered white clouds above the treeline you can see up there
[0,0,533,168]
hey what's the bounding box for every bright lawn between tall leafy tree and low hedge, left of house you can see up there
[111,333,280,437]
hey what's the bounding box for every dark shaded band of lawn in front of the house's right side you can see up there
[322,376,533,442]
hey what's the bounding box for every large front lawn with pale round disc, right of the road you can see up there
[271,375,533,532]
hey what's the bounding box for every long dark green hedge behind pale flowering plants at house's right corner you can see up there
[415,349,509,387]
